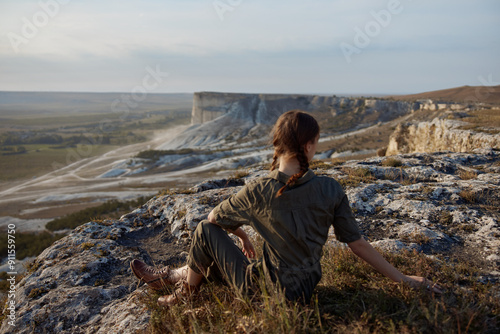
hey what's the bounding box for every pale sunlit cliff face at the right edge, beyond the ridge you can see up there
[386,118,500,155]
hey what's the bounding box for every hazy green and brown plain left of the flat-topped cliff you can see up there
[0,92,192,182]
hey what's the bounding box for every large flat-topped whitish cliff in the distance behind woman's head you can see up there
[157,92,465,150]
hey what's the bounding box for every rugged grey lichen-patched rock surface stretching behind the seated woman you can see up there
[1,150,500,333]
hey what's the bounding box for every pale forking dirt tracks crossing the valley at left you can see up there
[0,125,200,222]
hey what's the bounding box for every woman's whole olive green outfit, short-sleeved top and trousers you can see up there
[188,170,361,302]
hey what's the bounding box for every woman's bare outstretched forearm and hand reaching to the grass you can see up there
[348,237,441,293]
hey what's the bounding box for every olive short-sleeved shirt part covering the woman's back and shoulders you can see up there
[215,170,360,269]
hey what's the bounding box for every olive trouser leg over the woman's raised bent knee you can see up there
[188,220,250,291]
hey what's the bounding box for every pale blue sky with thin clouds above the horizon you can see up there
[0,0,500,95]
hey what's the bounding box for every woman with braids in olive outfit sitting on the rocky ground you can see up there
[131,110,440,306]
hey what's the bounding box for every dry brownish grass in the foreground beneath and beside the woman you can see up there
[137,246,500,333]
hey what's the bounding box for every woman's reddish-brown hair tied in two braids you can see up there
[271,110,319,197]
